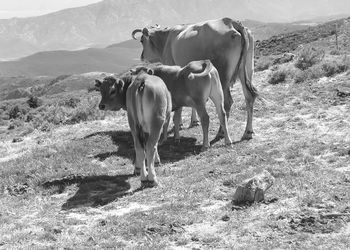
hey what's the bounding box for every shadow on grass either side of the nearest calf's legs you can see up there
[84,131,201,163]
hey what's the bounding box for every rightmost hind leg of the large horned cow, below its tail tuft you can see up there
[239,67,256,140]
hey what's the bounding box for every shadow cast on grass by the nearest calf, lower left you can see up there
[42,175,134,210]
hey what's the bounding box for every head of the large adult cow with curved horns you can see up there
[131,25,167,63]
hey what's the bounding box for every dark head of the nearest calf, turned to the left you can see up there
[95,76,125,111]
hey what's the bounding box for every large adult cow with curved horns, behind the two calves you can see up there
[131,18,258,140]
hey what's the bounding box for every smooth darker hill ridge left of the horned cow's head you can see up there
[0,40,141,77]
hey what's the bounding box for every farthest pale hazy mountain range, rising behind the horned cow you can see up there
[0,0,345,59]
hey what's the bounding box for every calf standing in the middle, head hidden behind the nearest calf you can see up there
[131,60,232,150]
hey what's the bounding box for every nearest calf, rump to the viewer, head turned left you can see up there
[95,73,172,187]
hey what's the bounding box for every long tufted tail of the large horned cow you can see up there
[231,20,259,98]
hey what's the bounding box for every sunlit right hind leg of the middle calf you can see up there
[210,86,232,145]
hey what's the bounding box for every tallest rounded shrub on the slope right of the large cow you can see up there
[294,46,325,70]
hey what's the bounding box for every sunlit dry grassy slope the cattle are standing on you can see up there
[0,52,350,249]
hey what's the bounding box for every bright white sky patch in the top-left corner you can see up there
[0,0,102,19]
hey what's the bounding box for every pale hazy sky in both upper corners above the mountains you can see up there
[0,0,350,21]
